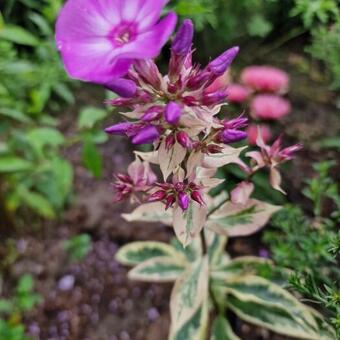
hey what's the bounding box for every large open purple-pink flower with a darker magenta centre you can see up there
[56,0,176,84]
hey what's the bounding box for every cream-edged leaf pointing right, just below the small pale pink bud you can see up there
[207,199,281,237]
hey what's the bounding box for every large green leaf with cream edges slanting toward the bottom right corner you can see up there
[215,275,319,340]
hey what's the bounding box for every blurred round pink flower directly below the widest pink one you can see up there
[250,94,291,120]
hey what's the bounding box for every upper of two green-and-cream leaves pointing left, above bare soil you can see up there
[116,241,186,266]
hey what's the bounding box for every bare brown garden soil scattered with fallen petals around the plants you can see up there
[4,54,340,340]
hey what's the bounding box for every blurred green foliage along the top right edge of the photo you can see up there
[169,0,340,89]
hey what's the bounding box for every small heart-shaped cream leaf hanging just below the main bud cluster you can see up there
[158,139,187,181]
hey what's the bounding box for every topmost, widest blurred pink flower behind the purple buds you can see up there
[241,66,289,93]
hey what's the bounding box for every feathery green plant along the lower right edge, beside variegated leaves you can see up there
[264,161,340,335]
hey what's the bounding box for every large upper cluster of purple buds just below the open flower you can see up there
[106,20,240,149]
